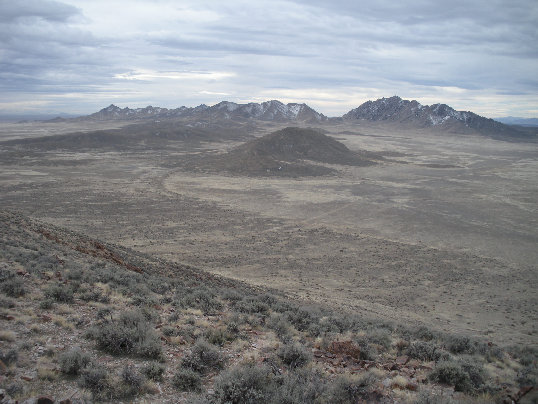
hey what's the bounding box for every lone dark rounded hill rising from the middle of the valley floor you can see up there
[196,127,381,176]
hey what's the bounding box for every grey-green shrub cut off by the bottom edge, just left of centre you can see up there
[214,365,274,404]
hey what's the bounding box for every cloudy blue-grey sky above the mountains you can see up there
[0,0,538,117]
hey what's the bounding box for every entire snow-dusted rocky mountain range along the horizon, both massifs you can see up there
[49,96,533,138]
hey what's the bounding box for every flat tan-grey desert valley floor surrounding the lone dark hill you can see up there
[0,119,538,345]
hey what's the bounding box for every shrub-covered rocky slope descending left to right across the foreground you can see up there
[0,211,536,403]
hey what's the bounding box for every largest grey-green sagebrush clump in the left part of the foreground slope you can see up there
[89,311,163,358]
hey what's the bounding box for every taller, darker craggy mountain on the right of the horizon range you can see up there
[343,96,525,136]
